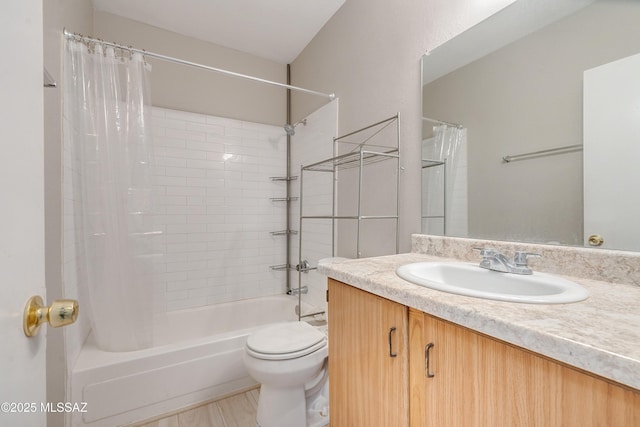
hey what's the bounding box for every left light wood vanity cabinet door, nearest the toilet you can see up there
[328,279,409,427]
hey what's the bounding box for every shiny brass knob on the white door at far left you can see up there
[23,296,78,337]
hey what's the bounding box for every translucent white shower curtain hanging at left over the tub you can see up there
[63,39,159,351]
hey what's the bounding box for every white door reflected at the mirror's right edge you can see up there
[583,54,640,251]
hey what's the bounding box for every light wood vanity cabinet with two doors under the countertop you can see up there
[328,279,640,427]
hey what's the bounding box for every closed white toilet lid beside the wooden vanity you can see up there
[247,322,327,360]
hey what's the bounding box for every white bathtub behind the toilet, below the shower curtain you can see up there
[68,295,316,427]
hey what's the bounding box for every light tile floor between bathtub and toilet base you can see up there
[131,388,260,427]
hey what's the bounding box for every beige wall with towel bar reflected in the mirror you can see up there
[424,2,640,245]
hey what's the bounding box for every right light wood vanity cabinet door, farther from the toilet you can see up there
[409,309,640,427]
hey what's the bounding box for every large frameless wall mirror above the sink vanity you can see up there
[422,0,640,250]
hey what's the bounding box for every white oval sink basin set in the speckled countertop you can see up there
[396,262,589,304]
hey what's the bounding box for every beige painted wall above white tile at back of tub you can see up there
[94,11,287,126]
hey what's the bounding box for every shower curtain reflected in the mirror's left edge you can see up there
[422,125,468,237]
